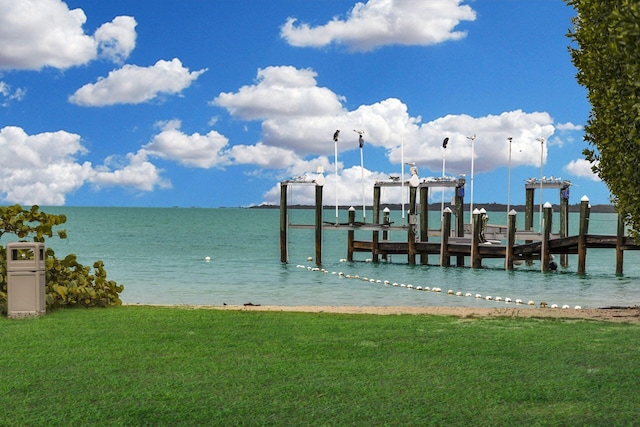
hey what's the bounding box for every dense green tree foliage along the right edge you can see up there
[565,0,640,237]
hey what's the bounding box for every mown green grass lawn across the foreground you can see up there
[0,306,640,426]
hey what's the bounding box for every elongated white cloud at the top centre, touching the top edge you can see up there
[280,0,476,51]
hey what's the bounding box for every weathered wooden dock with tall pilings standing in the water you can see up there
[280,178,640,274]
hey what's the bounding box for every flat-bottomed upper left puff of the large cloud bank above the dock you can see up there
[211,66,343,120]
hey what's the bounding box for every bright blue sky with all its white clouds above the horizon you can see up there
[0,0,610,207]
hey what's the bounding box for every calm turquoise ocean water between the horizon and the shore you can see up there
[2,207,640,308]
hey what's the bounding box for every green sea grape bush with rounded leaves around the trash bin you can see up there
[0,205,124,313]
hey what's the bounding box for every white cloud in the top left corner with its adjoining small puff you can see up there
[0,0,135,70]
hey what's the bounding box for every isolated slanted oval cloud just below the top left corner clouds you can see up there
[69,58,206,107]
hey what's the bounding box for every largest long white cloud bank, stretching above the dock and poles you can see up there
[212,67,573,187]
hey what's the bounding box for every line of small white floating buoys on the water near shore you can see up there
[296,259,582,310]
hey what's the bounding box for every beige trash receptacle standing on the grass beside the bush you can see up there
[7,242,47,318]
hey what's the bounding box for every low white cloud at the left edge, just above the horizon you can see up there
[0,126,166,205]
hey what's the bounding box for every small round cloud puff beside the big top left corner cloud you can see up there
[95,16,137,63]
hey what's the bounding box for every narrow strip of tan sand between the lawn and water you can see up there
[144,304,640,324]
